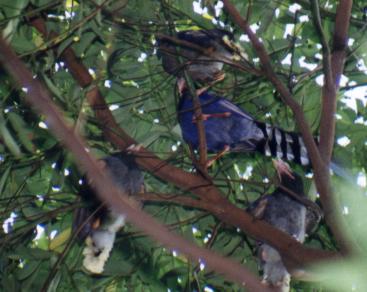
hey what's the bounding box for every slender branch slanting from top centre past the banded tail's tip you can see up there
[223,0,354,251]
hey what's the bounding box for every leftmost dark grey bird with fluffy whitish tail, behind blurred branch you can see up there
[73,153,144,274]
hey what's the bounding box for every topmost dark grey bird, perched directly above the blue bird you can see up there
[157,29,246,83]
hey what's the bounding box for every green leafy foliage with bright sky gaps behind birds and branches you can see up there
[0,0,367,291]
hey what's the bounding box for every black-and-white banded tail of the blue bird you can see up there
[256,122,310,166]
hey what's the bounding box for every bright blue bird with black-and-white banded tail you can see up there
[177,80,310,166]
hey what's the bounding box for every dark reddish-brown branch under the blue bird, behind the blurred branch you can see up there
[28,18,335,266]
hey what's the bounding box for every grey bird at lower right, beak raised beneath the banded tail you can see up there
[248,160,321,292]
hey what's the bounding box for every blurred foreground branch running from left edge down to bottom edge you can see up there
[0,39,270,291]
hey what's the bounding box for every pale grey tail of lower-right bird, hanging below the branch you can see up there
[260,244,291,292]
